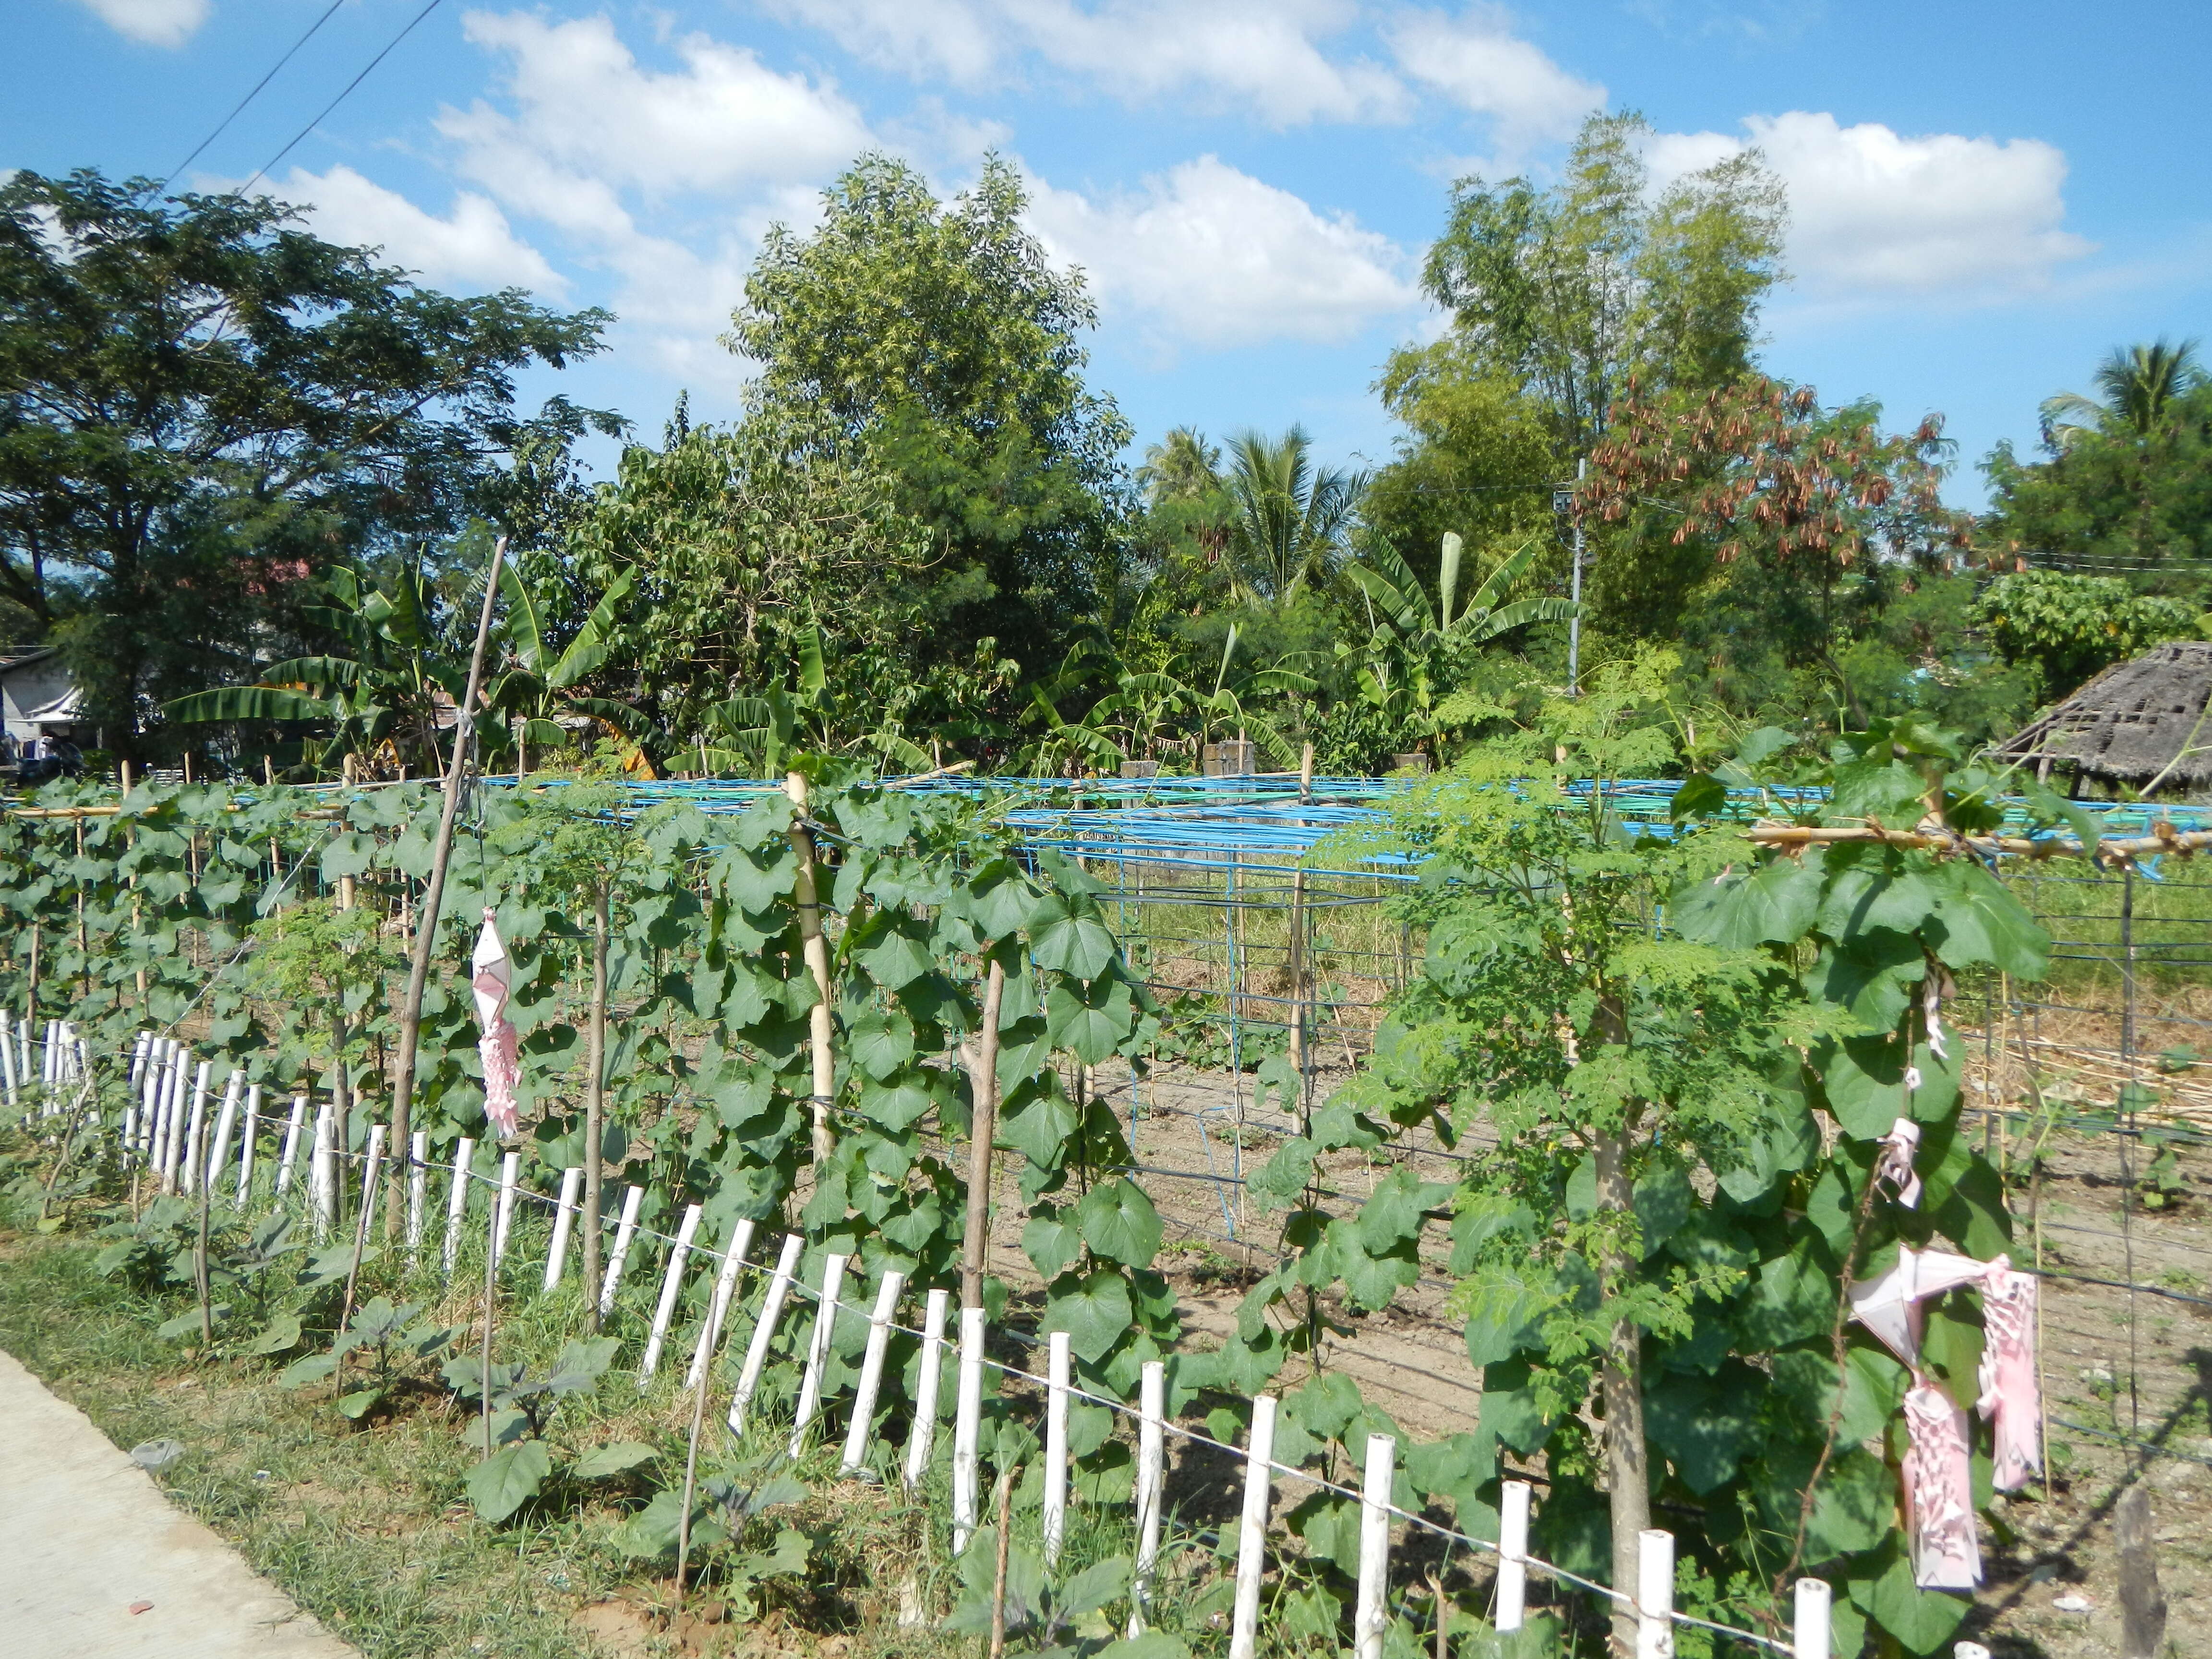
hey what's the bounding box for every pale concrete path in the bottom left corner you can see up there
[0,1354,361,1659]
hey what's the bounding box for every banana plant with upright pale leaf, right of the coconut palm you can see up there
[1338,531,1577,741]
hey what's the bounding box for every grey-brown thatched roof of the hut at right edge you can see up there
[1997,639,2212,794]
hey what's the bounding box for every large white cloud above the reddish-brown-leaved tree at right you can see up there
[1650,110,2091,299]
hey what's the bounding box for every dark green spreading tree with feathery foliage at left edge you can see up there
[0,170,608,748]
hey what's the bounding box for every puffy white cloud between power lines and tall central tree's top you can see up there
[438,11,869,195]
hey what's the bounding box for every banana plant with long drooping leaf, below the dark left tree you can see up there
[164,568,465,772]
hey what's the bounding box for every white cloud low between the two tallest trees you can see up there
[1029,155,1418,347]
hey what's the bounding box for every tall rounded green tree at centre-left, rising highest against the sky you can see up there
[728,155,1130,670]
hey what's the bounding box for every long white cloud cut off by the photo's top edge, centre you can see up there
[770,0,1411,126]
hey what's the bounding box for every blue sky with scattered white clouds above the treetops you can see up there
[17,0,2212,505]
